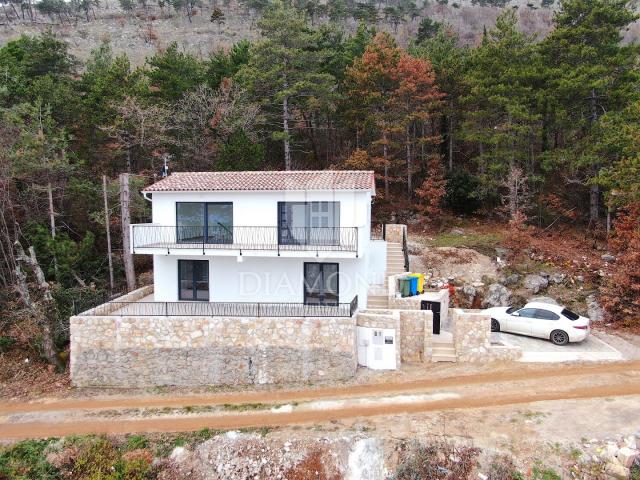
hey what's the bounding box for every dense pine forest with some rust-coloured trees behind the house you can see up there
[0,0,640,366]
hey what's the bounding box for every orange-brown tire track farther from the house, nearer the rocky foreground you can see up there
[0,382,640,440]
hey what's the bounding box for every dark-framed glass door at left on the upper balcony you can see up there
[176,202,233,243]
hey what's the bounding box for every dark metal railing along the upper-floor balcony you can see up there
[131,224,358,254]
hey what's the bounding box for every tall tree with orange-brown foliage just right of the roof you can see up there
[346,33,444,213]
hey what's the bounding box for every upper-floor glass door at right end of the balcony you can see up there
[278,202,340,245]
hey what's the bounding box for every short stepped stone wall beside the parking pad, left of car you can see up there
[452,308,522,362]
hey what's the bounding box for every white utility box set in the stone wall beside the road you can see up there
[358,327,397,370]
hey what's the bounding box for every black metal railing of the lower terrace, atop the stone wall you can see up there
[84,295,358,317]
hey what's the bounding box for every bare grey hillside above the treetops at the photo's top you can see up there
[0,0,560,64]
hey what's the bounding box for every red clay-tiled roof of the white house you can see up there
[143,170,375,193]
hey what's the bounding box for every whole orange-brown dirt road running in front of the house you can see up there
[0,361,640,439]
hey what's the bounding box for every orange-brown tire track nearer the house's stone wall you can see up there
[0,360,640,416]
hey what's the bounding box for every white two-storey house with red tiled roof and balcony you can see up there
[131,170,386,315]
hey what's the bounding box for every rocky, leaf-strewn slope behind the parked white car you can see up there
[409,223,615,323]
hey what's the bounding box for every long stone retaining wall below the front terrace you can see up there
[71,315,357,387]
